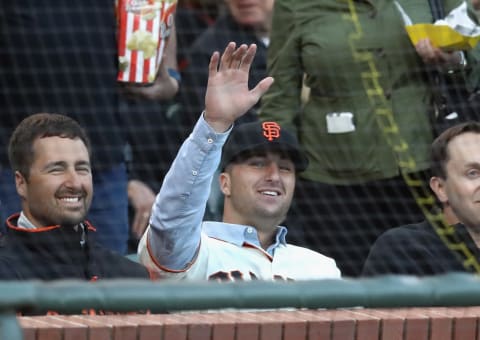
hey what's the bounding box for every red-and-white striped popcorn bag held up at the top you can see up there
[117,0,177,84]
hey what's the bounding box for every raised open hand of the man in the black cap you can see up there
[205,42,273,132]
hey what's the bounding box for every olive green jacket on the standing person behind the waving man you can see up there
[260,0,474,184]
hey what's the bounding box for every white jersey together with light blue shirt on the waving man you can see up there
[138,117,340,280]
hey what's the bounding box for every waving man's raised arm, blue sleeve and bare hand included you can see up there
[138,43,273,271]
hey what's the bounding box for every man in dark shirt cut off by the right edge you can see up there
[363,122,480,276]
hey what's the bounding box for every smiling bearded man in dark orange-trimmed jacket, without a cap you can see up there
[0,113,149,281]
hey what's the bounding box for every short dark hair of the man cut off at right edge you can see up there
[430,121,480,179]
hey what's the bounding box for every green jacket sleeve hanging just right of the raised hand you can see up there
[260,0,304,133]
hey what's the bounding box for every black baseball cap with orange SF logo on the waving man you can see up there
[220,121,308,172]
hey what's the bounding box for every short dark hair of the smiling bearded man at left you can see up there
[8,113,91,178]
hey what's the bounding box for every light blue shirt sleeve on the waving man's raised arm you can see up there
[148,114,231,270]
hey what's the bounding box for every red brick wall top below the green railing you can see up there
[18,307,480,340]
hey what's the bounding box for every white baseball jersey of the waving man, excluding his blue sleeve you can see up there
[140,222,340,281]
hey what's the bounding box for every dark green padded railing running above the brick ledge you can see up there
[0,273,480,340]
